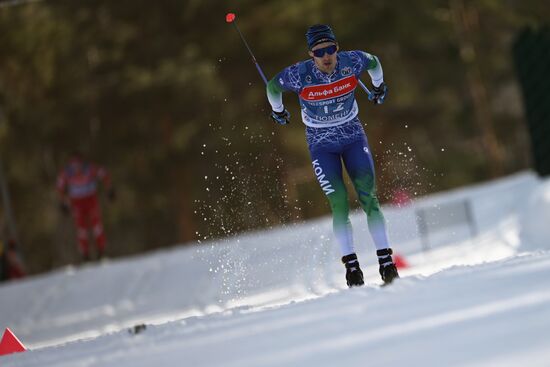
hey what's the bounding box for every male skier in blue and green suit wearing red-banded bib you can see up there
[267,24,399,287]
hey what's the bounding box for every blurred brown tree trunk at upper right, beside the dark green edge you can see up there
[449,0,504,177]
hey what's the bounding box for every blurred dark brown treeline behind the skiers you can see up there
[0,0,550,272]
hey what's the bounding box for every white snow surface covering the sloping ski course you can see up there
[0,172,550,367]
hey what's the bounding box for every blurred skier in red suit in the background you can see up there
[57,153,115,261]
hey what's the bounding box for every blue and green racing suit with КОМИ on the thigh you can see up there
[267,51,389,256]
